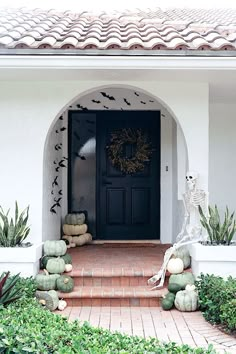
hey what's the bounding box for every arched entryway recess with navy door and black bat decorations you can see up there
[43,86,187,243]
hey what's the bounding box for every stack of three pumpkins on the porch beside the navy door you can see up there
[62,213,92,248]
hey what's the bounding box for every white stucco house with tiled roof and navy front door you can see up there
[0,8,236,270]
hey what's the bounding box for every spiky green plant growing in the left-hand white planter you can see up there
[0,202,30,247]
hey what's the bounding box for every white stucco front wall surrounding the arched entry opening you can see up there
[0,79,208,246]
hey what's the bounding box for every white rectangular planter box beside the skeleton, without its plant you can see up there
[189,243,236,278]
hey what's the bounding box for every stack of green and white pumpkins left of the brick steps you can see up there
[35,240,74,311]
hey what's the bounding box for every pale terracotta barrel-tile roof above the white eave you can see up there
[0,8,236,51]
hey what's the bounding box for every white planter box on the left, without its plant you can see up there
[0,244,42,277]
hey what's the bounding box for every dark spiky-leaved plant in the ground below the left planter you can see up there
[0,272,21,306]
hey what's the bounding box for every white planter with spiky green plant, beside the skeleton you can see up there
[189,206,236,278]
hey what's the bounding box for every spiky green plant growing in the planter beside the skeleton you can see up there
[199,205,236,245]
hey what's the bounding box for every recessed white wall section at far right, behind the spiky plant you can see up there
[209,103,236,211]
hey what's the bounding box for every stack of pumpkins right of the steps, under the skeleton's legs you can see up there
[161,247,198,312]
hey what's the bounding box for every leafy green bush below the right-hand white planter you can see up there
[196,274,236,331]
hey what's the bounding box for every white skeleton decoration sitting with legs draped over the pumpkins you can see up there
[148,171,208,289]
